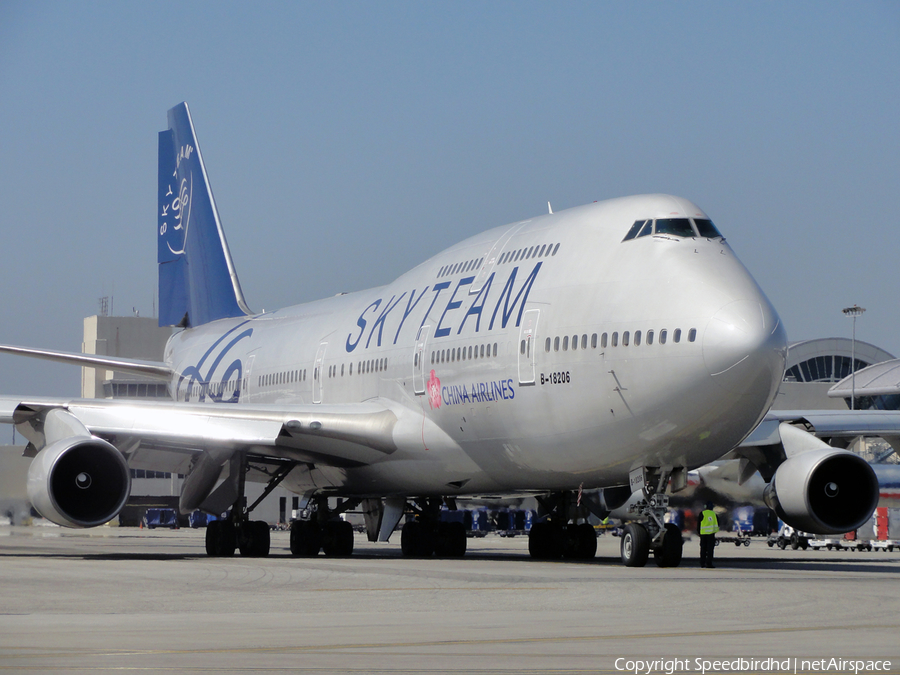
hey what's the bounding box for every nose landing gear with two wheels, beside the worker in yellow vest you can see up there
[619,468,684,567]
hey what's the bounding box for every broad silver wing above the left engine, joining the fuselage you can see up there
[0,397,398,473]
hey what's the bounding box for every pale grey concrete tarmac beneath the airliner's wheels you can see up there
[0,527,900,675]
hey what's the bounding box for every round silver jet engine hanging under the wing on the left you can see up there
[28,436,131,527]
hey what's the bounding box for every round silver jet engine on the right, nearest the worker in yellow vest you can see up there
[765,449,879,534]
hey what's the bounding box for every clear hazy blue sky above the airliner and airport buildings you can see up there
[0,0,900,395]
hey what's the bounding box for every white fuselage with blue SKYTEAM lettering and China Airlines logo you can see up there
[166,195,786,495]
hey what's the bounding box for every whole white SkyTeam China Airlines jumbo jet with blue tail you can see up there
[0,103,877,566]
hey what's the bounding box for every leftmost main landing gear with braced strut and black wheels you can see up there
[206,461,293,558]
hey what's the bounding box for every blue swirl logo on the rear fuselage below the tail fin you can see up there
[175,320,253,403]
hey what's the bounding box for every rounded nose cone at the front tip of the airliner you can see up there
[703,299,787,401]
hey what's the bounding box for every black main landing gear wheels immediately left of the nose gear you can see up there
[528,492,597,560]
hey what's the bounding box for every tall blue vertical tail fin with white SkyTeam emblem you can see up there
[157,103,250,327]
